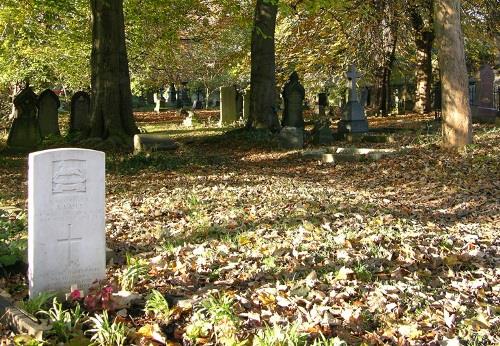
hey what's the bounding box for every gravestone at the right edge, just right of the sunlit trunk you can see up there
[471,65,498,124]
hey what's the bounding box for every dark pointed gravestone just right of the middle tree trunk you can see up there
[281,72,305,128]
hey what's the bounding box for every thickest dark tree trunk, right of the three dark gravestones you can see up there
[90,0,139,144]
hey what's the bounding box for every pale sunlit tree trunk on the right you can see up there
[435,0,472,147]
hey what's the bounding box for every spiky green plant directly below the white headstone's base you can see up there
[40,298,85,342]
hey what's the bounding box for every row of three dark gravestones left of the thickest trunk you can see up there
[7,87,90,149]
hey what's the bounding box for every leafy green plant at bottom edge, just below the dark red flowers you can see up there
[87,310,128,346]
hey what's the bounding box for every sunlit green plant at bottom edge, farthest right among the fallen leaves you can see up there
[253,324,307,346]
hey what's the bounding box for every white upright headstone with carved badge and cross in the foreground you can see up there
[28,149,106,298]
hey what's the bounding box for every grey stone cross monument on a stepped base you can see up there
[338,65,368,133]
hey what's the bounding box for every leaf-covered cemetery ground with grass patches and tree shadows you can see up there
[0,113,500,345]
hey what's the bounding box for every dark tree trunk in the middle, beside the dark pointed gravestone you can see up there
[247,0,280,132]
